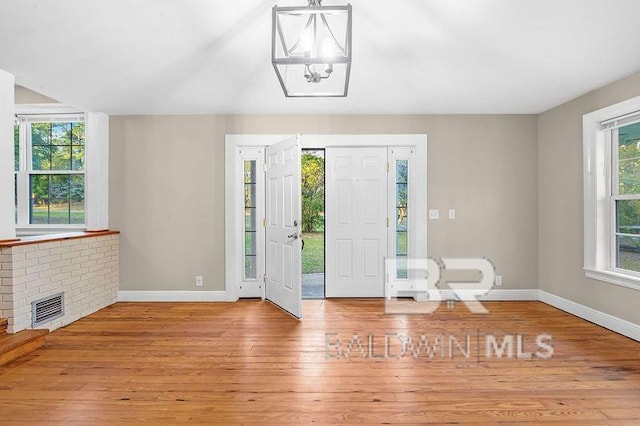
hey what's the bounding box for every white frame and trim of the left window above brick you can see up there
[11,104,109,236]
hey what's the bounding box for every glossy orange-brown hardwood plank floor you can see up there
[0,300,640,425]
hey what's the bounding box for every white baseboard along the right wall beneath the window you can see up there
[538,290,640,341]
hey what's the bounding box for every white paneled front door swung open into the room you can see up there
[265,137,302,318]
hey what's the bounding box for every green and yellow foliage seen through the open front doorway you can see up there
[302,153,324,232]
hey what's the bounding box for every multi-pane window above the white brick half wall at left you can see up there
[14,115,86,227]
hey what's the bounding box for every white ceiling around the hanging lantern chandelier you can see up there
[0,0,640,114]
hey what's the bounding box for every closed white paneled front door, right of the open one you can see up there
[325,147,387,297]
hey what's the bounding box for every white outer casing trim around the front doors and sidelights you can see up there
[225,134,427,300]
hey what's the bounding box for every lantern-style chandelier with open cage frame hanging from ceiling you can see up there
[271,0,351,97]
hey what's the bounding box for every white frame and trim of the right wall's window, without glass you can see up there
[582,96,640,290]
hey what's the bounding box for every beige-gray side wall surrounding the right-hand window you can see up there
[538,73,640,324]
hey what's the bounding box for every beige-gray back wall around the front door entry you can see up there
[109,115,538,290]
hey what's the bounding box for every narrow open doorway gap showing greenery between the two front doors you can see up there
[301,149,325,299]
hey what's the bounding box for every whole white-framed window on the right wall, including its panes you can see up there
[583,97,640,289]
